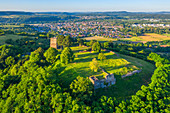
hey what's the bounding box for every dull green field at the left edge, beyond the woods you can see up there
[0,34,34,45]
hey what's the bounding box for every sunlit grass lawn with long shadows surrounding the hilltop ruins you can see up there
[60,47,155,99]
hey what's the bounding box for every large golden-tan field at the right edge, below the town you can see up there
[122,33,170,42]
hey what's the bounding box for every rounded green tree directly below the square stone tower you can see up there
[44,47,58,63]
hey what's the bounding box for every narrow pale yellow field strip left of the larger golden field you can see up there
[83,36,117,42]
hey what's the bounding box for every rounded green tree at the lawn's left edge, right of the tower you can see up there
[60,47,74,64]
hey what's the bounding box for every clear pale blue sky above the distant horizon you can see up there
[0,0,170,12]
